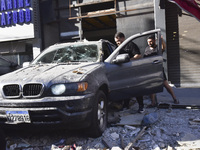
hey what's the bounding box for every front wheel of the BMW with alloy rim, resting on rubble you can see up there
[89,91,108,137]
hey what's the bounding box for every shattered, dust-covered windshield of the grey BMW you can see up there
[32,44,98,64]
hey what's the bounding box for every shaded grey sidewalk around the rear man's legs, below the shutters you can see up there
[157,87,200,107]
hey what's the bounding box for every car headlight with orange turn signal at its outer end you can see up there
[51,82,88,95]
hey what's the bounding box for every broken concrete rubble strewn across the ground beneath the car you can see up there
[3,101,200,150]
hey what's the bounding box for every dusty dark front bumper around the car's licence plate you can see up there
[0,94,94,129]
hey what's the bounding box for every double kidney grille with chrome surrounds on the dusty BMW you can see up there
[3,83,44,98]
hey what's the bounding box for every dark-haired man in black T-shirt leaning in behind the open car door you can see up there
[114,32,144,113]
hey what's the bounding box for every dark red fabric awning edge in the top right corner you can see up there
[168,0,200,21]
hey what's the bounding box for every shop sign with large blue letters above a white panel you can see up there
[0,0,38,42]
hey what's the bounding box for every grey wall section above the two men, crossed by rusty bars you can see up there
[116,0,154,37]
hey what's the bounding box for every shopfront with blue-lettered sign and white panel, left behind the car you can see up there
[0,0,40,65]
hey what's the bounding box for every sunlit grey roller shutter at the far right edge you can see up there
[179,11,200,87]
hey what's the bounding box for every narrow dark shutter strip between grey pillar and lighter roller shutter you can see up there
[166,1,180,86]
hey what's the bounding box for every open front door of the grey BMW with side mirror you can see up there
[105,30,163,100]
